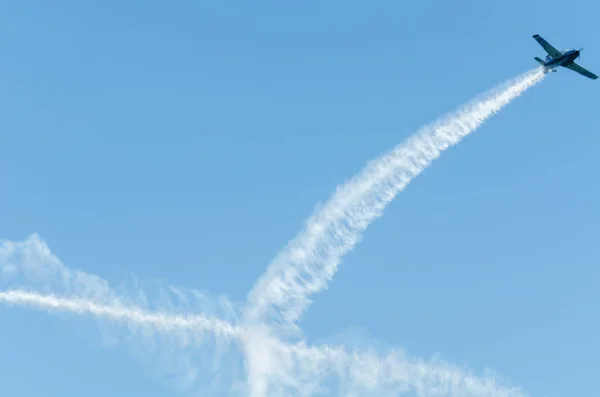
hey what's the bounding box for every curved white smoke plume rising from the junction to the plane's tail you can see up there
[244,68,544,331]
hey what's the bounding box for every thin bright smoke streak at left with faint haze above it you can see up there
[0,234,240,337]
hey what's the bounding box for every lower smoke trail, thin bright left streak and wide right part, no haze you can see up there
[0,290,524,397]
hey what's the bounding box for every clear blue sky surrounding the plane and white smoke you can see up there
[0,0,600,397]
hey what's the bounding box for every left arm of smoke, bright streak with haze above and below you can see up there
[0,235,244,395]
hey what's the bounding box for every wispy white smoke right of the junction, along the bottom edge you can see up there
[239,324,525,397]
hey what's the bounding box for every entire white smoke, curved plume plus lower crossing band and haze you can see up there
[0,69,544,397]
